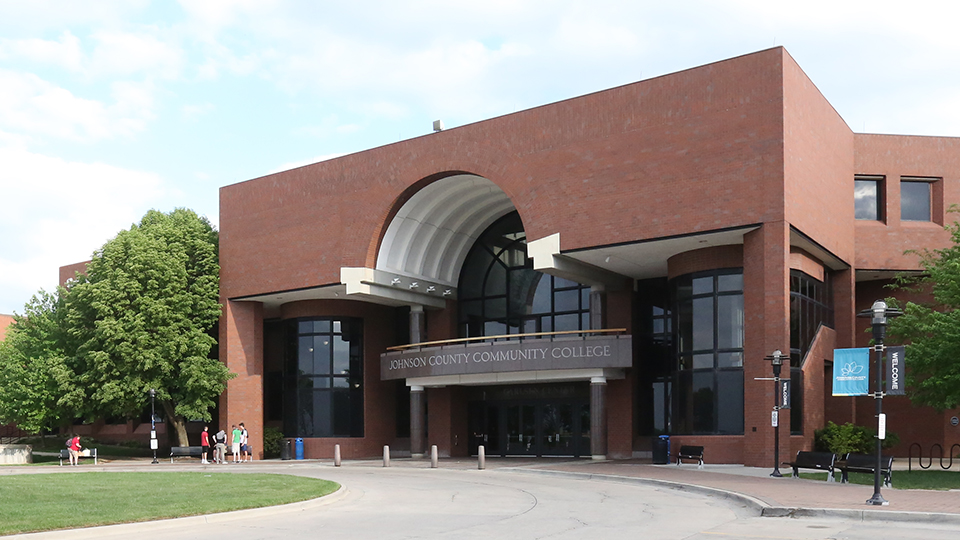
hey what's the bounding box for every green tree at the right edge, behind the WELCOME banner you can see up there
[889,215,960,410]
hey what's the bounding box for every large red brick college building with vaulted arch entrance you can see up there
[210,47,960,465]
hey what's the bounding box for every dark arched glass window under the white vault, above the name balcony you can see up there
[458,212,590,337]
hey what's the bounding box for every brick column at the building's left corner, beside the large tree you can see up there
[220,300,263,459]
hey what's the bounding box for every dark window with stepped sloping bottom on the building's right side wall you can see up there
[790,270,833,435]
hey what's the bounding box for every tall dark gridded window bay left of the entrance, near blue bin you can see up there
[284,318,363,437]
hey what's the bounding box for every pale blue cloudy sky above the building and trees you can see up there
[0,0,960,314]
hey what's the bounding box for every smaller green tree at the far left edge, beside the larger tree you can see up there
[0,288,85,432]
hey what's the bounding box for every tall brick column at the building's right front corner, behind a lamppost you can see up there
[743,221,790,471]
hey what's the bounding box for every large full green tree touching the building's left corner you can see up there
[65,209,233,446]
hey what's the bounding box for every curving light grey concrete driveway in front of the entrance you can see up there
[7,463,958,540]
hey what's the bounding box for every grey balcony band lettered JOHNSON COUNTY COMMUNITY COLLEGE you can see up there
[380,335,633,380]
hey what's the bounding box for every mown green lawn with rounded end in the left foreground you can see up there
[0,472,340,535]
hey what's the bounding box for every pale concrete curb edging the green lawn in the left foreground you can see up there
[3,485,347,540]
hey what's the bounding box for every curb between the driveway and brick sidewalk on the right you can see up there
[510,467,960,525]
